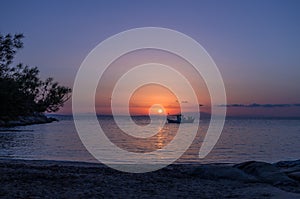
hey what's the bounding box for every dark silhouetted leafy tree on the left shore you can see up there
[0,34,71,116]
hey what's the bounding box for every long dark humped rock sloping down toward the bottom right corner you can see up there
[234,161,298,186]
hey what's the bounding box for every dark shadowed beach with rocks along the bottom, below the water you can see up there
[0,159,300,198]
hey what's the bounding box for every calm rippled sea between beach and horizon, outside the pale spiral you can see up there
[0,116,300,163]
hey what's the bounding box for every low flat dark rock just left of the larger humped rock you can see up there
[190,165,258,182]
